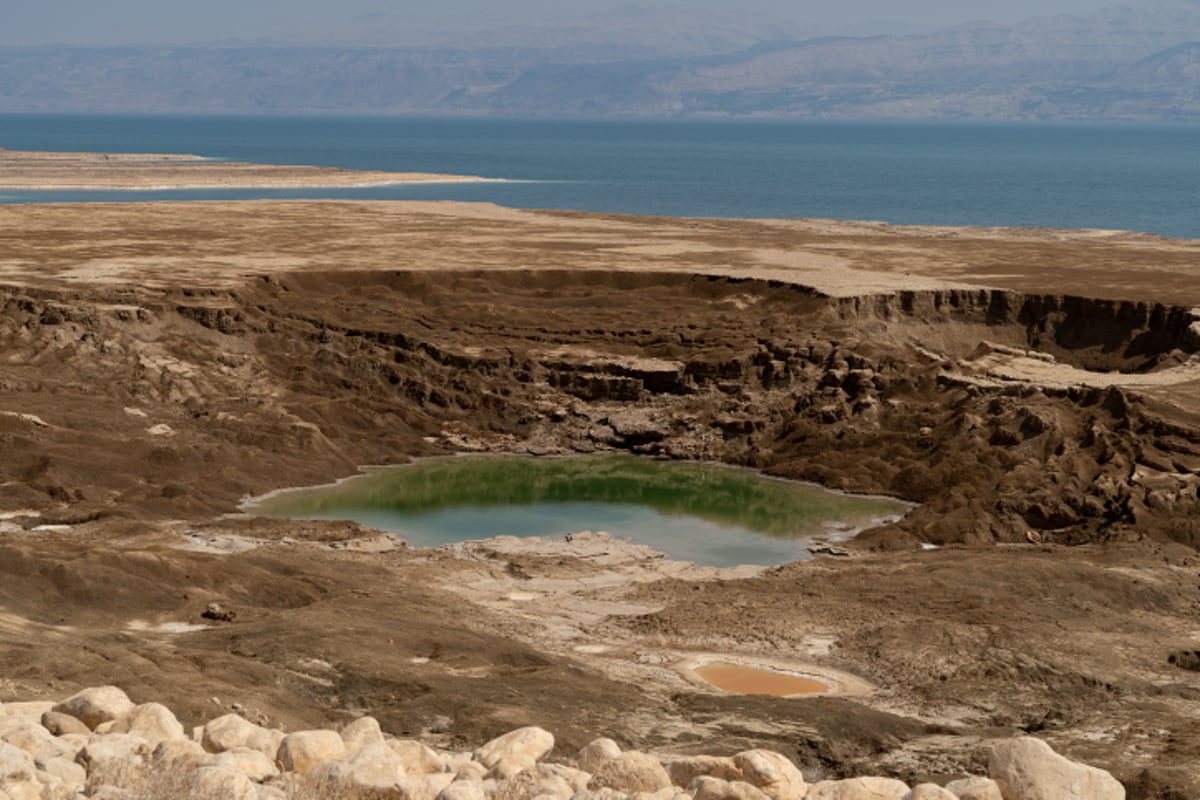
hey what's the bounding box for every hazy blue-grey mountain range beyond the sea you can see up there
[0,0,1200,120]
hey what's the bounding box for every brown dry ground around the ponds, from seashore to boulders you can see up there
[0,196,1200,798]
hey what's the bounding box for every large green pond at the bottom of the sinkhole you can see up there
[246,456,910,566]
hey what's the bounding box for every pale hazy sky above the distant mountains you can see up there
[0,0,1123,44]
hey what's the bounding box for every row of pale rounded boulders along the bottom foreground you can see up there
[0,686,1126,800]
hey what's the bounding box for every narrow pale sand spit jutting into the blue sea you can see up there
[0,149,494,191]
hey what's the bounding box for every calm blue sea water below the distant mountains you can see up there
[0,115,1200,239]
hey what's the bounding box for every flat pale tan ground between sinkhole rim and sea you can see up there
[0,200,1200,307]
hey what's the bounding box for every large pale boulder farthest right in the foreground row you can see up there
[988,736,1126,800]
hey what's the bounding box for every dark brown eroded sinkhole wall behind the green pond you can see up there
[0,271,1200,548]
